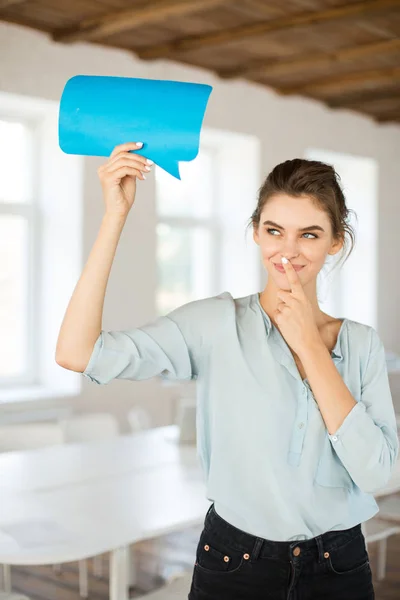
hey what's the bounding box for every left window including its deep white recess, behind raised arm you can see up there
[0,92,83,404]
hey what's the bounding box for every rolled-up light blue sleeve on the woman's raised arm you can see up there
[82,292,234,385]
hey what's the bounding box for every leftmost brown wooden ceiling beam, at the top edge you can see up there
[52,0,227,43]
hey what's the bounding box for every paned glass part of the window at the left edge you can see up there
[0,117,38,386]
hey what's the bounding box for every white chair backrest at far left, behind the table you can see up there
[0,423,64,452]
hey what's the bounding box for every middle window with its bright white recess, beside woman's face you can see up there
[155,128,261,315]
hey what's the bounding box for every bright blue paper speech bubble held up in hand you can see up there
[58,75,212,179]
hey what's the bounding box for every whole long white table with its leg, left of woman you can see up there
[0,427,209,600]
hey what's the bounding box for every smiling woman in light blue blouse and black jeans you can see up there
[56,143,399,600]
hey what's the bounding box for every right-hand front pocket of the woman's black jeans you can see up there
[327,535,370,575]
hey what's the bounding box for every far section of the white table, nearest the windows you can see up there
[0,425,192,492]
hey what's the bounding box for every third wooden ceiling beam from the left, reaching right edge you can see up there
[218,38,400,79]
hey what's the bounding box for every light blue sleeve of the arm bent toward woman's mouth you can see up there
[329,328,399,493]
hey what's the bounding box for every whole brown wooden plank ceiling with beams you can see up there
[0,0,400,123]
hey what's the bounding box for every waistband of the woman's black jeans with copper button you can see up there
[204,504,363,562]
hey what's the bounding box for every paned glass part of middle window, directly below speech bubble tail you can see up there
[155,148,220,314]
